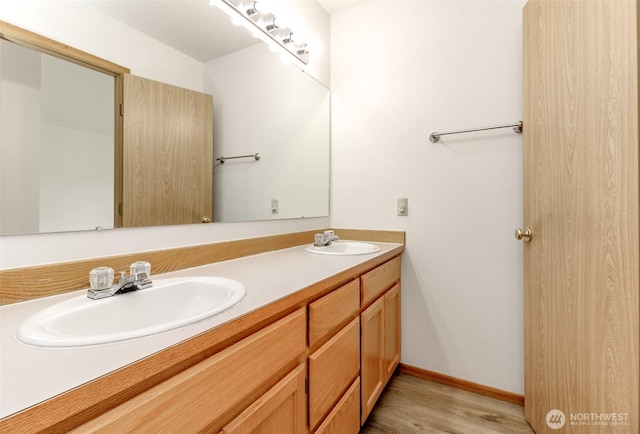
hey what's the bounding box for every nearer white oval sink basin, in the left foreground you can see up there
[16,277,246,347]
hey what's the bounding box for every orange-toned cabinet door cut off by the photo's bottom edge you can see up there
[222,364,307,434]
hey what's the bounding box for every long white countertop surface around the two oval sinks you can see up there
[0,242,404,419]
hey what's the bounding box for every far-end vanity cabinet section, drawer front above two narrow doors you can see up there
[360,257,400,424]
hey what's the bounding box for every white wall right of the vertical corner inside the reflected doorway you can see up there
[38,55,114,233]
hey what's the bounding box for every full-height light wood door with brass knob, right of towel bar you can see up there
[523,0,640,433]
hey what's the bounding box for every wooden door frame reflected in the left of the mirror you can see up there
[0,20,131,228]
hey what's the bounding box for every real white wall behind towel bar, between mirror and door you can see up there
[331,0,526,393]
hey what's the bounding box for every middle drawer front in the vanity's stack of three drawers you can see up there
[309,318,360,429]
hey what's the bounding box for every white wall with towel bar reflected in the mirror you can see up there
[205,44,329,222]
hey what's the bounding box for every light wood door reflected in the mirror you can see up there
[121,74,213,227]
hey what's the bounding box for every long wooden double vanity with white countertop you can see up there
[0,231,404,433]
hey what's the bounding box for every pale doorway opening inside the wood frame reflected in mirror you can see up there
[0,40,114,234]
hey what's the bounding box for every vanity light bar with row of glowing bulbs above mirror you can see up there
[208,0,309,69]
